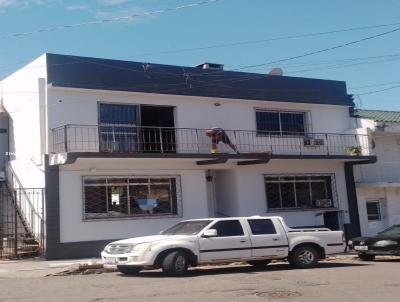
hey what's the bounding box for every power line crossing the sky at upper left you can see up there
[0,0,223,39]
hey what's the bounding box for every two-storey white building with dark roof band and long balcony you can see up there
[1,54,375,259]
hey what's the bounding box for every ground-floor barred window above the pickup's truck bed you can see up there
[264,174,336,209]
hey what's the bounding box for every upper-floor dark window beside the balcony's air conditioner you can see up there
[256,110,305,135]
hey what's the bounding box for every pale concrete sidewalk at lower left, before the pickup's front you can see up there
[0,258,101,280]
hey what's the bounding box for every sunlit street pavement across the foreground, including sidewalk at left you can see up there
[0,256,400,302]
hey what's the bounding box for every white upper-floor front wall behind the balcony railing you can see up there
[48,87,350,153]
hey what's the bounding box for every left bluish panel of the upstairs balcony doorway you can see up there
[99,104,138,152]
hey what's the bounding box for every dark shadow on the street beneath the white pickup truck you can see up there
[119,262,373,278]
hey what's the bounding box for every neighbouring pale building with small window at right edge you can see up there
[355,110,400,235]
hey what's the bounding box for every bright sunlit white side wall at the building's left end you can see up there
[0,55,46,188]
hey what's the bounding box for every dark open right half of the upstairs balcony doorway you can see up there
[140,105,176,153]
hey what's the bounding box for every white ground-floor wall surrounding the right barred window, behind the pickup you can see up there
[216,160,348,227]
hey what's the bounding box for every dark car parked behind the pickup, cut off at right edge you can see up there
[349,225,400,261]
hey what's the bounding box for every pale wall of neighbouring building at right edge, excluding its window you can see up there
[354,119,400,236]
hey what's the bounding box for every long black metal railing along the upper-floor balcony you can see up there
[52,125,370,155]
